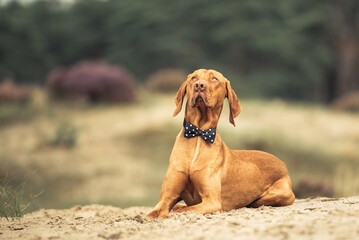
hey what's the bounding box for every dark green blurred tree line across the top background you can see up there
[0,0,354,99]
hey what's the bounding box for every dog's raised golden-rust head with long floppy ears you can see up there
[173,69,241,126]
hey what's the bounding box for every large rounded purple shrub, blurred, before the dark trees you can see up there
[46,61,136,102]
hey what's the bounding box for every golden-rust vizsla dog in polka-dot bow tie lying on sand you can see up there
[148,69,295,218]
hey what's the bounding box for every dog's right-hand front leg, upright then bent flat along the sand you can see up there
[176,173,222,214]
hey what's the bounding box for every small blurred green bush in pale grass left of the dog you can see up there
[50,121,77,148]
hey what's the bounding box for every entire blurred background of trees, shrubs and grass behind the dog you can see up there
[0,0,359,214]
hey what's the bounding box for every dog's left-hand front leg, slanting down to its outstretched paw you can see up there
[147,168,188,218]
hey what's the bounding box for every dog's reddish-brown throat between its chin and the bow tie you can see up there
[185,103,222,129]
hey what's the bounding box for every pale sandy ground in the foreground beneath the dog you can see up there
[0,196,359,240]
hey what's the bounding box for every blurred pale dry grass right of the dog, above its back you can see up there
[222,101,359,196]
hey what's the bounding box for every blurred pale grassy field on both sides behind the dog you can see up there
[0,90,359,212]
